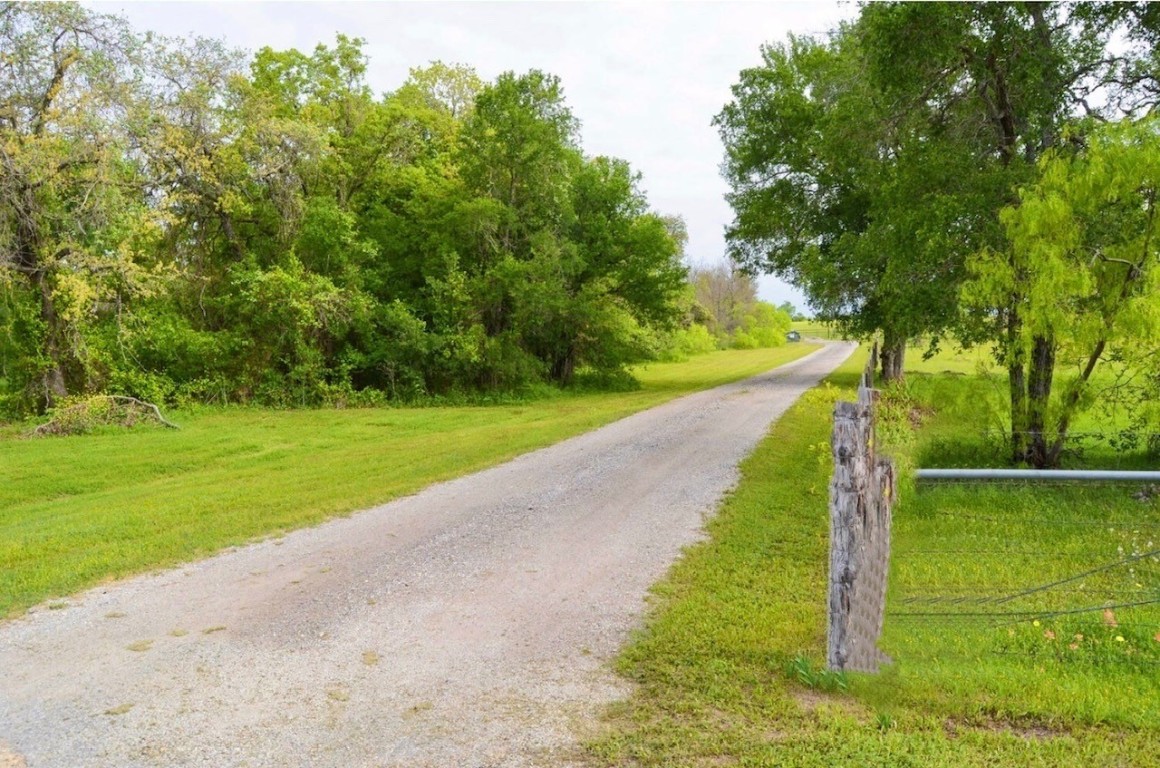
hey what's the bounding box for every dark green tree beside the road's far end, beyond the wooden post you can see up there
[716,27,977,379]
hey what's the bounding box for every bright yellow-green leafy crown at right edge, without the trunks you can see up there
[964,119,1160,352]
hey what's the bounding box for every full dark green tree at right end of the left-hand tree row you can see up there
[447,71,684,384]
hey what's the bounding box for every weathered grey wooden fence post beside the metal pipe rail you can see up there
[826,347,896,672]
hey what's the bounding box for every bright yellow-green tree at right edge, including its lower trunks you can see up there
[963,119,1160,466]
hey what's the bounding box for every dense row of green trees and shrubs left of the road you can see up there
[0,3,687,415]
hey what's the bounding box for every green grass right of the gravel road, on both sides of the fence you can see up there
[592,345,1160,768]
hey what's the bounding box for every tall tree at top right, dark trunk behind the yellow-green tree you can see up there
[861,3,1157,466]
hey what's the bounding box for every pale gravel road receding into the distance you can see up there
[0,343,854,768]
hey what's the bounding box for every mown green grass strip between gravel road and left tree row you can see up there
[0,345,813,617]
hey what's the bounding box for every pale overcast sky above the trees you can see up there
[95,1,855,306]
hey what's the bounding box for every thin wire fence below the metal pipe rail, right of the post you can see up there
[882,484,1160,668]
